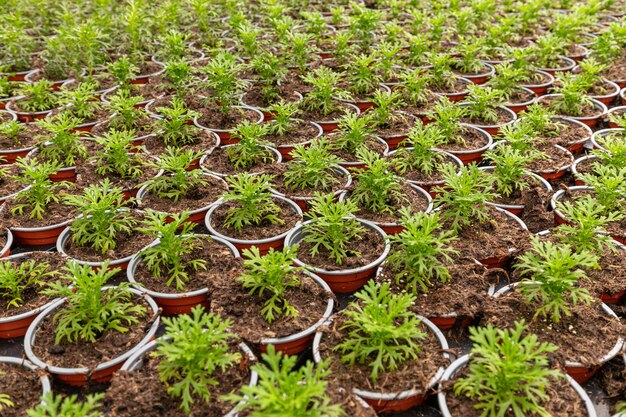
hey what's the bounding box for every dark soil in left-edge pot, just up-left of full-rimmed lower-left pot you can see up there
[0,252,67,317]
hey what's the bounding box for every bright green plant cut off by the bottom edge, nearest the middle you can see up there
[228,346,375,417]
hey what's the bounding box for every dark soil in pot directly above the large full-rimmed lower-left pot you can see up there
[65,212,154,262]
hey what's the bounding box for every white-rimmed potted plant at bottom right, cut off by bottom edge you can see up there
[438,320,596,417]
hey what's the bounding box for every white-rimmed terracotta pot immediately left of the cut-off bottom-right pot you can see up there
[313,314,453,413]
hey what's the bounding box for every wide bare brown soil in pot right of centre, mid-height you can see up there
[444,207,529,260]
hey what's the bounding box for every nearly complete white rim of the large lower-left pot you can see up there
[24,286,160,375]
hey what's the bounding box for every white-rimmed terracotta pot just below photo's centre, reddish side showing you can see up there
[285,220,391,293]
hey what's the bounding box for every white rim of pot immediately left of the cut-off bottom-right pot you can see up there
[313,314,455,401]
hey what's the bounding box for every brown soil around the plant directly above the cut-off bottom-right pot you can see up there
[481,284,623,365]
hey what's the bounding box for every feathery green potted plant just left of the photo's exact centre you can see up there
[205,173,302,253]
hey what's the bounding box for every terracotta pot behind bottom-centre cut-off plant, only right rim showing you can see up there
[259,271,335,355]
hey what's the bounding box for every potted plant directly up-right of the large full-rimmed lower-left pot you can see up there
[127,210,239,315]
